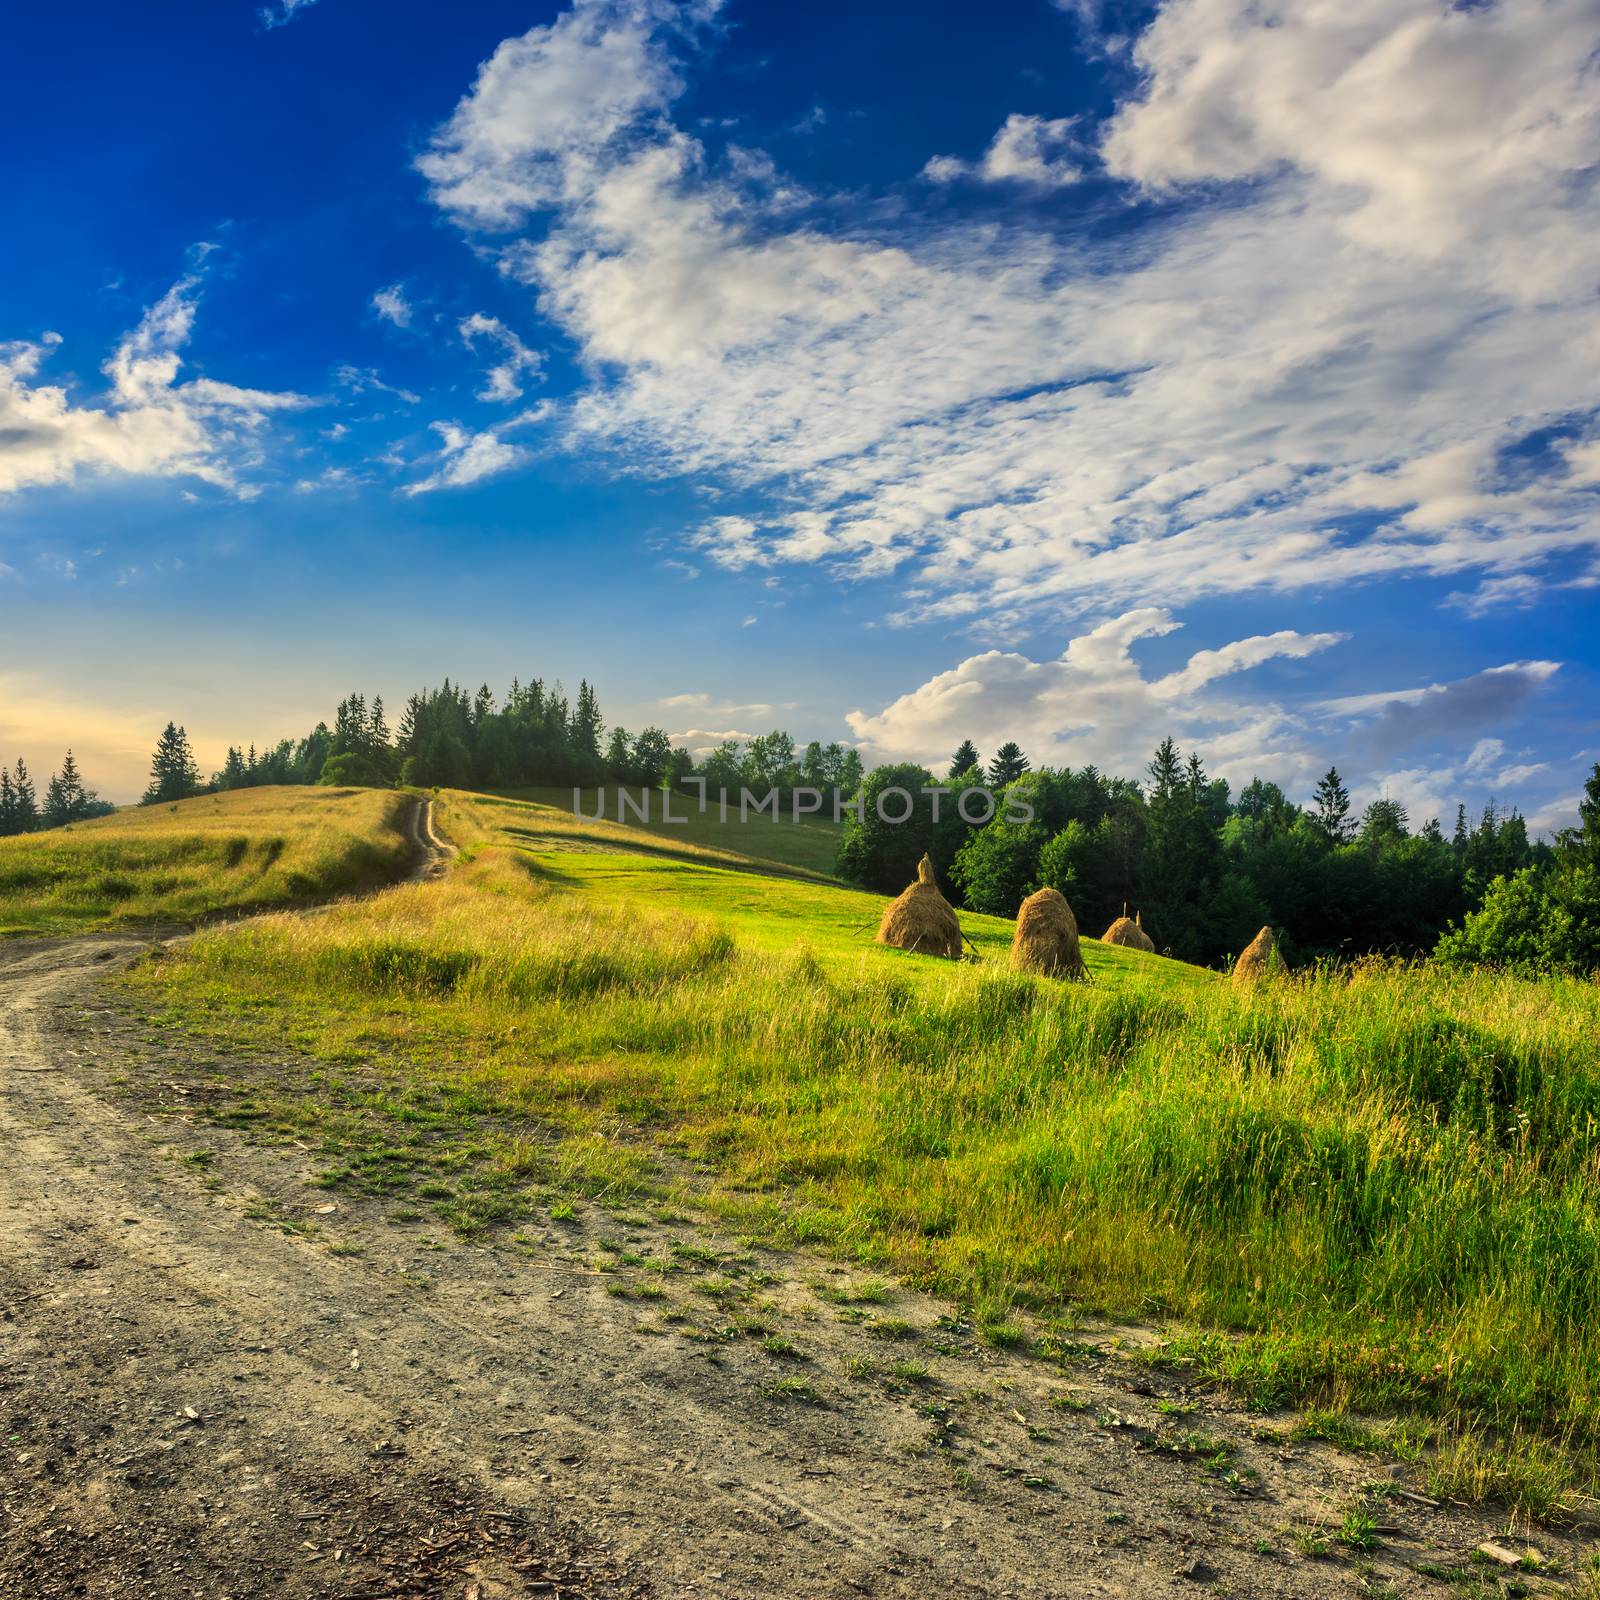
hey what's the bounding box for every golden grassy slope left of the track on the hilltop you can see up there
[0,789,411,938]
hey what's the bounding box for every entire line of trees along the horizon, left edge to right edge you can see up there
[0,678,1600,971]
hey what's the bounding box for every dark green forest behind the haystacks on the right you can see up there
[838,739,1600,971]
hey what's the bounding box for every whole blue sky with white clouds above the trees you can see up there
[0,0,1600,832]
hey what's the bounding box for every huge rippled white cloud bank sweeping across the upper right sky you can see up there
[421,0,1600,624]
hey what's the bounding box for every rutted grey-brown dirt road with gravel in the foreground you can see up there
[0,844,1581,1600]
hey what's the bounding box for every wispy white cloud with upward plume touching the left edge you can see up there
[0,278,314,498]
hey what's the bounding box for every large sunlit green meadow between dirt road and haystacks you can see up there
[139,780,1600,1504]
